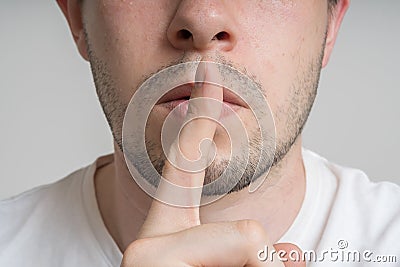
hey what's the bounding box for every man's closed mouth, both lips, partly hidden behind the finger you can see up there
[156,83,249,117]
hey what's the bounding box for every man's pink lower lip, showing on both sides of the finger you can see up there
[158,99,242,119]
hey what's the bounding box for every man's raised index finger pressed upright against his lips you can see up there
[138,62,223,238]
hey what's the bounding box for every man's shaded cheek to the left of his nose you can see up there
[86,0,172,100]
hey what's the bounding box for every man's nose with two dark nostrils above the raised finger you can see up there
[167,0,237,51]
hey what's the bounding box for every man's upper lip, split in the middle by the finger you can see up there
[157,83,248,108]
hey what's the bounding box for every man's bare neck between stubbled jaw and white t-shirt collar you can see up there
[95,137,305,251]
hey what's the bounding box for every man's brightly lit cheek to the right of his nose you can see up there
[234,0,327,114]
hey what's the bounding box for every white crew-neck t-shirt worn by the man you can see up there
[0,150,400,267]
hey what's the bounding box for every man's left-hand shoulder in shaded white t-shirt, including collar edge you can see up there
[0,155,122,267]
